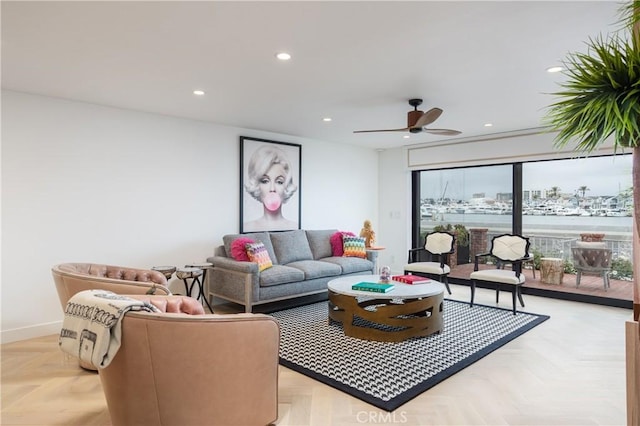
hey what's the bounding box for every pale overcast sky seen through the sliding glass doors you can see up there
[421,155,632,200]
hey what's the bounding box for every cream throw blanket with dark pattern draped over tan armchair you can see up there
[58,290,158,368]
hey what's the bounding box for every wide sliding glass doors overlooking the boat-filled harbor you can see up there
[412,154,633,286]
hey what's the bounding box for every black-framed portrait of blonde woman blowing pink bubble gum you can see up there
[240,136,302,233]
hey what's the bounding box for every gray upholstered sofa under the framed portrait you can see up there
[207,229,378,312]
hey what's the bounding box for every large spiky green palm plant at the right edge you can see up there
[545,0,640,320]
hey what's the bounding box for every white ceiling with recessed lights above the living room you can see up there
[1,1,619,149]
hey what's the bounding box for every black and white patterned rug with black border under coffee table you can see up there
[270,299,549,411]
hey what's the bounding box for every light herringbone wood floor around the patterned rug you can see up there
[0,285,631,426]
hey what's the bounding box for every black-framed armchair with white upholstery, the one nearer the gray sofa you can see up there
[404,232,456,294]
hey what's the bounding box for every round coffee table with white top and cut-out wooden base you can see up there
[327,275,444,342]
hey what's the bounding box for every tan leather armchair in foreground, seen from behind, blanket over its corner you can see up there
[98,312,280,426]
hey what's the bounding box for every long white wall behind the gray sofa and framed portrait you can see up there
[0,91,379,343]
